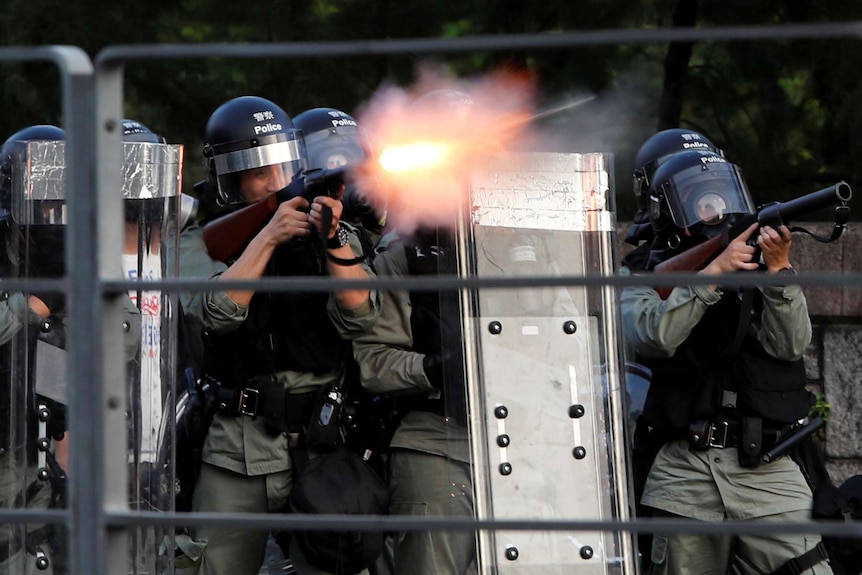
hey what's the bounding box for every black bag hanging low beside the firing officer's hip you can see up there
[287,446,389,575]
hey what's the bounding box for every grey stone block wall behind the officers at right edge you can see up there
[619,223,862,483]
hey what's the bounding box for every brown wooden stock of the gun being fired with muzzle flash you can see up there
[204,194,279,262]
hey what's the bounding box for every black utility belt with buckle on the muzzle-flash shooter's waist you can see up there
[209,378,318,433]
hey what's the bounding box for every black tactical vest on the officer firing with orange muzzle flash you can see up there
[204,242,350,387]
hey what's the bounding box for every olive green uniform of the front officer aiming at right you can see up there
[621,276,831,575]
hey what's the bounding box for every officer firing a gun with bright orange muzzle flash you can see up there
[180,96,376,575]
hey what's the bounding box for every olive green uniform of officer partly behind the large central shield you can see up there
[353,234,476,575]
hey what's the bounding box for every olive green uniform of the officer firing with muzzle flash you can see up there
[178,226,378,575]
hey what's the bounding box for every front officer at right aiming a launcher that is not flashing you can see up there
[621,146,828,574]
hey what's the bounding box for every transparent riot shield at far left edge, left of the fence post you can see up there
[0,137,68,575]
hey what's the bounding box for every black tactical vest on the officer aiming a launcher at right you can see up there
[638,290,812,437]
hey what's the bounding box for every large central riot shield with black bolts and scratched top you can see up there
[460,153,636,575]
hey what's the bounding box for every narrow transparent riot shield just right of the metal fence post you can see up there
[122,142,183,574]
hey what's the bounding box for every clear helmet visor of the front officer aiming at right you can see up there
[662,163,754,228]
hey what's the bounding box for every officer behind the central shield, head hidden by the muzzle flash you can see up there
[353,90,476,575]
